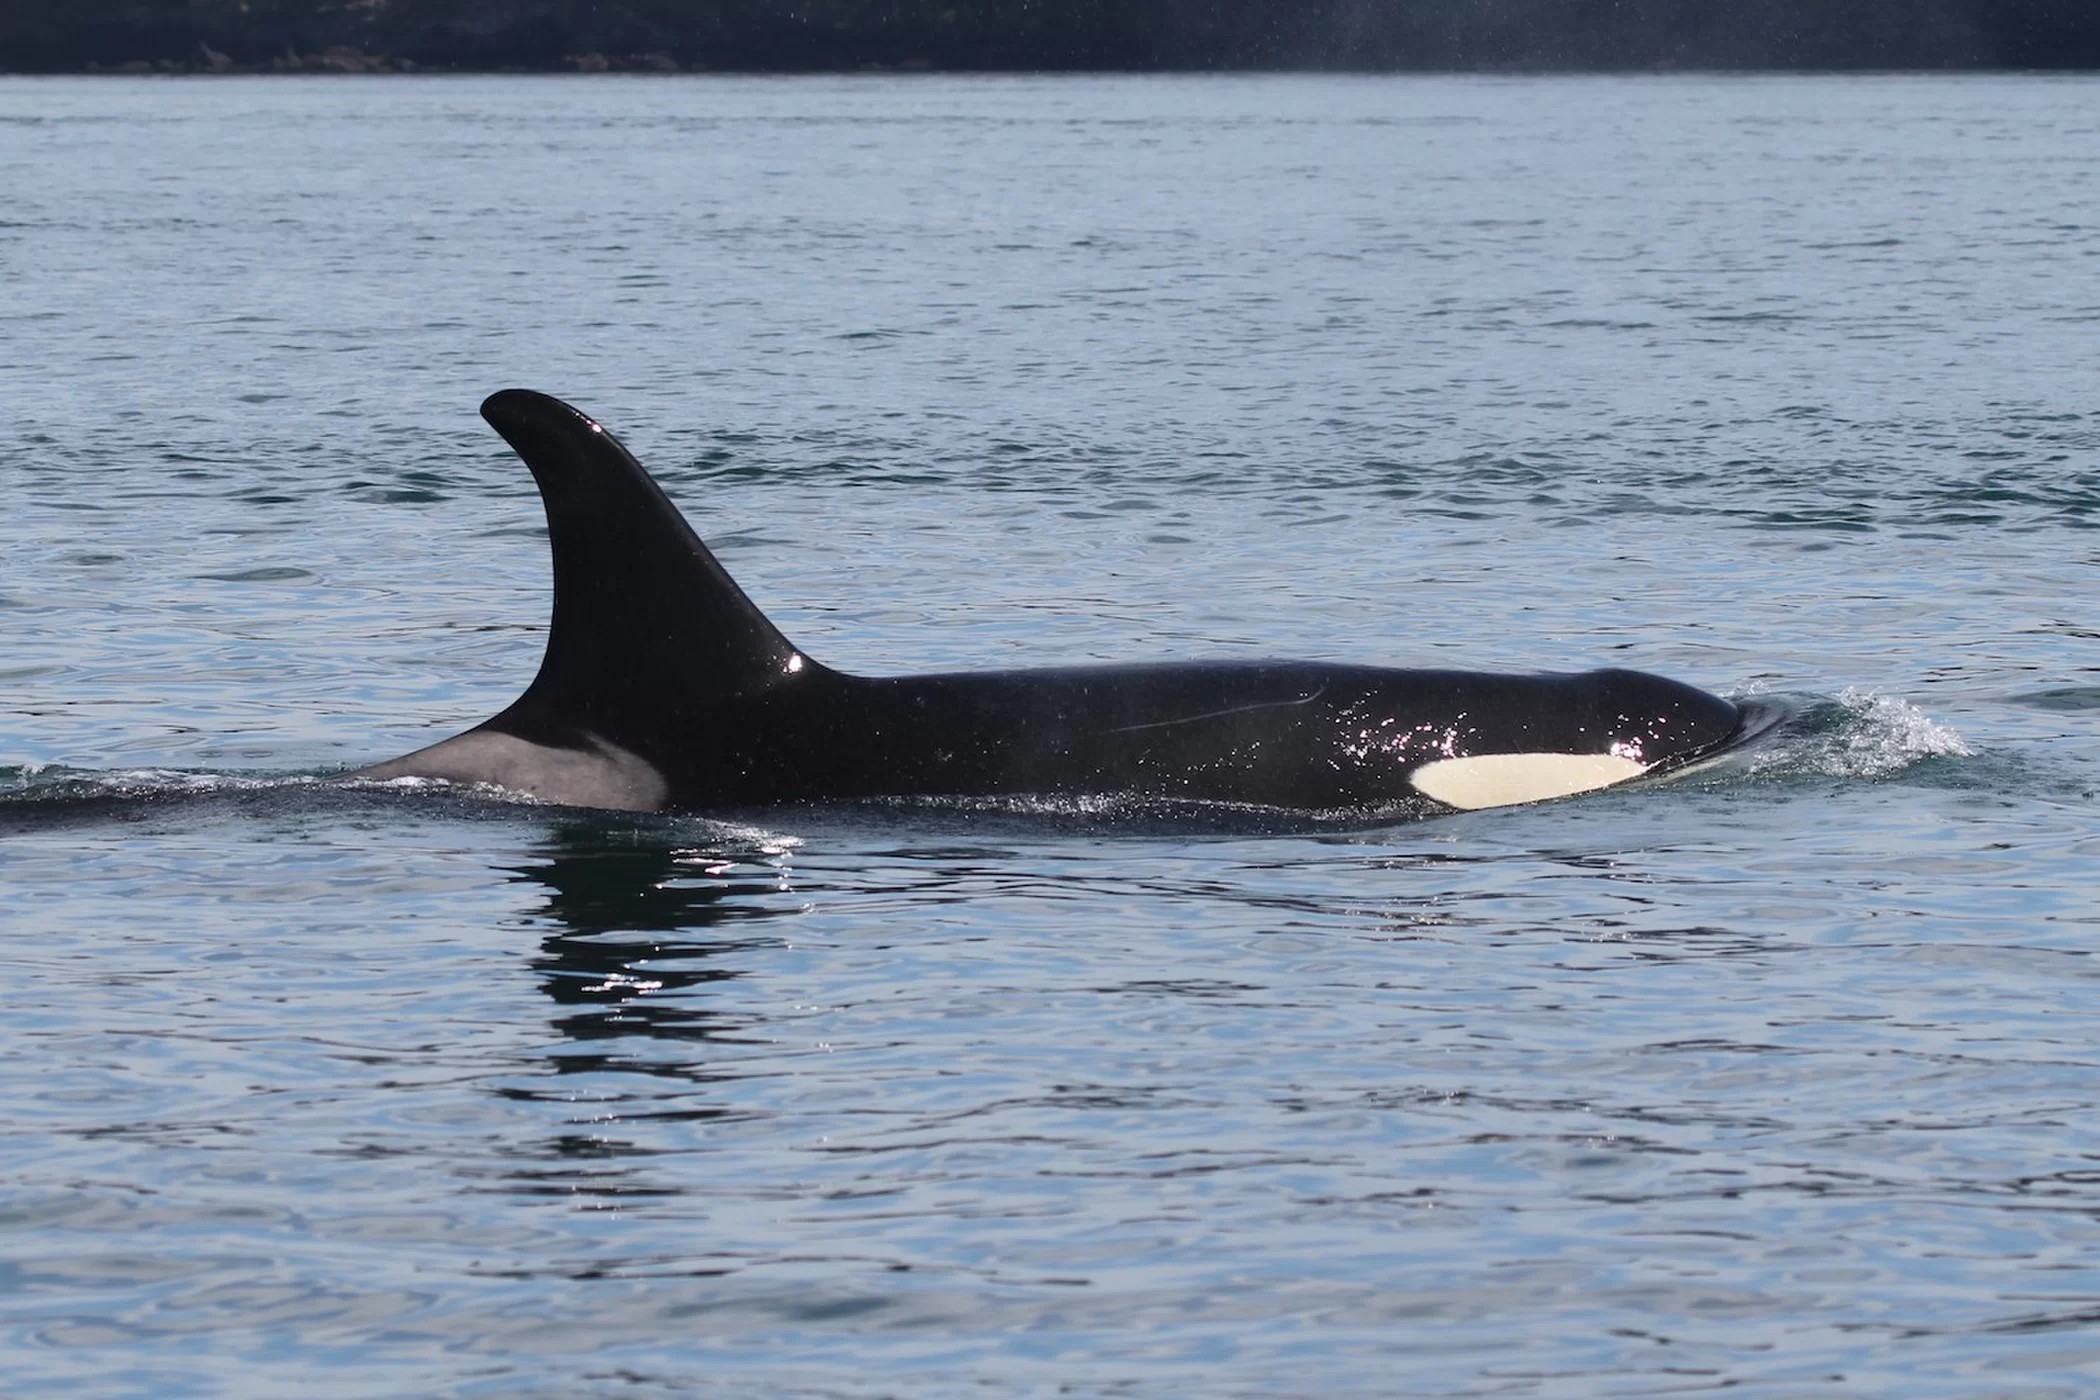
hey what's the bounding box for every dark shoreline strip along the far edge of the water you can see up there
[12,0,2100,71]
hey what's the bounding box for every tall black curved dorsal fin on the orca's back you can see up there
[481,388,821,751]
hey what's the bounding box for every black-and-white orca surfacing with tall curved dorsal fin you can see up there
[342,388,1756,816]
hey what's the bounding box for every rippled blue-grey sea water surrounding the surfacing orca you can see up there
[0,76,2100,1400]
